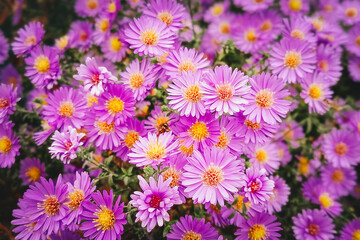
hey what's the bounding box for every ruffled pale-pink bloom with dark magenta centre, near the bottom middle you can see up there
[130,175,181,232]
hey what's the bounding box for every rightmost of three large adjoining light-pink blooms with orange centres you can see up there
[243,73,291,124]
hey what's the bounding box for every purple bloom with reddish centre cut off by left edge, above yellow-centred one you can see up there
[0,84,20,124]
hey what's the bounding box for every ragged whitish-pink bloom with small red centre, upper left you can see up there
[74,57,117,96]
